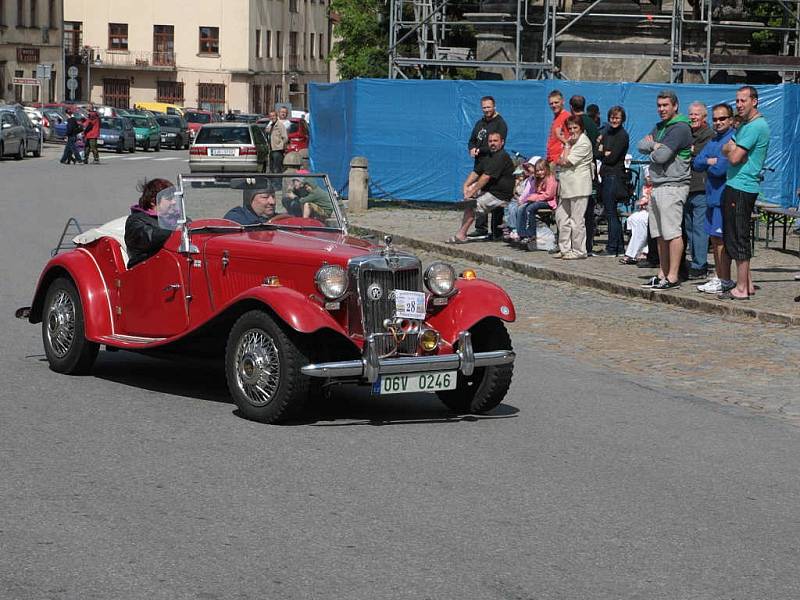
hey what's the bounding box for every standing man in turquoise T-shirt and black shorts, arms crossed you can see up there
[719,85,769,300]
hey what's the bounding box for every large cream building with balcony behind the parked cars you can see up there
[64,0,330,112]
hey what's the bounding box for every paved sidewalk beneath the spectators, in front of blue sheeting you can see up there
[350,206,800,325]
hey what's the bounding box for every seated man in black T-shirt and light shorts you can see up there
[447,132,515,244]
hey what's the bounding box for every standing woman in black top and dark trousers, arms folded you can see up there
[597,106,630,256]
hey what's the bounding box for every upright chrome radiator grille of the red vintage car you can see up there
[358,266,422,355]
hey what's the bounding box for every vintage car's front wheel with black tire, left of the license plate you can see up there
[225,310,311,423]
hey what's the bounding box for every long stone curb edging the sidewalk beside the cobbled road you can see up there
[353,225,800,326]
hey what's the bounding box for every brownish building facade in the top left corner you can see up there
[0,0,63,103]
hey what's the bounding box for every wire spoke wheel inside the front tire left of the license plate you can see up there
[236,329,281,406]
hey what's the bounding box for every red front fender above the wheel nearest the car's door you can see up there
[223,285,350,339]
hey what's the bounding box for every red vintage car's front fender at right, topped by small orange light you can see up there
[427,279,517,344]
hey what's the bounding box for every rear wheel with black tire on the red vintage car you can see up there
[42,277,100,375]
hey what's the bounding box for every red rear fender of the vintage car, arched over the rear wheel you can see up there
[28,248,113,340]
